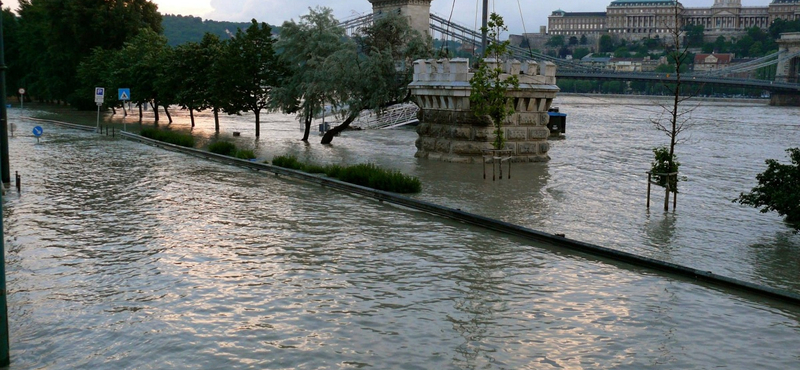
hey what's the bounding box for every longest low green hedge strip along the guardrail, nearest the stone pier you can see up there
[272,156,422,193]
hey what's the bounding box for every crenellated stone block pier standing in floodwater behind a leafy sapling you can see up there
[409,58,559,163]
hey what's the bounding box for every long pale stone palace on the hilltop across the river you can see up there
[548,0,800,40]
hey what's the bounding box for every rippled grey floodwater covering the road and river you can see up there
[3,96,800,369]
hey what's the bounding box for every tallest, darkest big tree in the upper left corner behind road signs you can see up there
[19,0,161,107]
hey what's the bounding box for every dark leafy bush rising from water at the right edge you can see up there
[734,148,800,230]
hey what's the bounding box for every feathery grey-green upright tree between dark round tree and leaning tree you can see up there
[275,7,345,141]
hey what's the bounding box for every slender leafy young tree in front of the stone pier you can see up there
[469,13,519,149]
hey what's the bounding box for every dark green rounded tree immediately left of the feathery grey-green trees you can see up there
[218,19,287,137]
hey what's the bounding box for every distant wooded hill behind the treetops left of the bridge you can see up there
[161,14,278,46]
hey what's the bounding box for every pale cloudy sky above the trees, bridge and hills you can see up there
[3,0,771,34]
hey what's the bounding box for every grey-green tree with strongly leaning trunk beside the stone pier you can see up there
[322,13,433,144]
